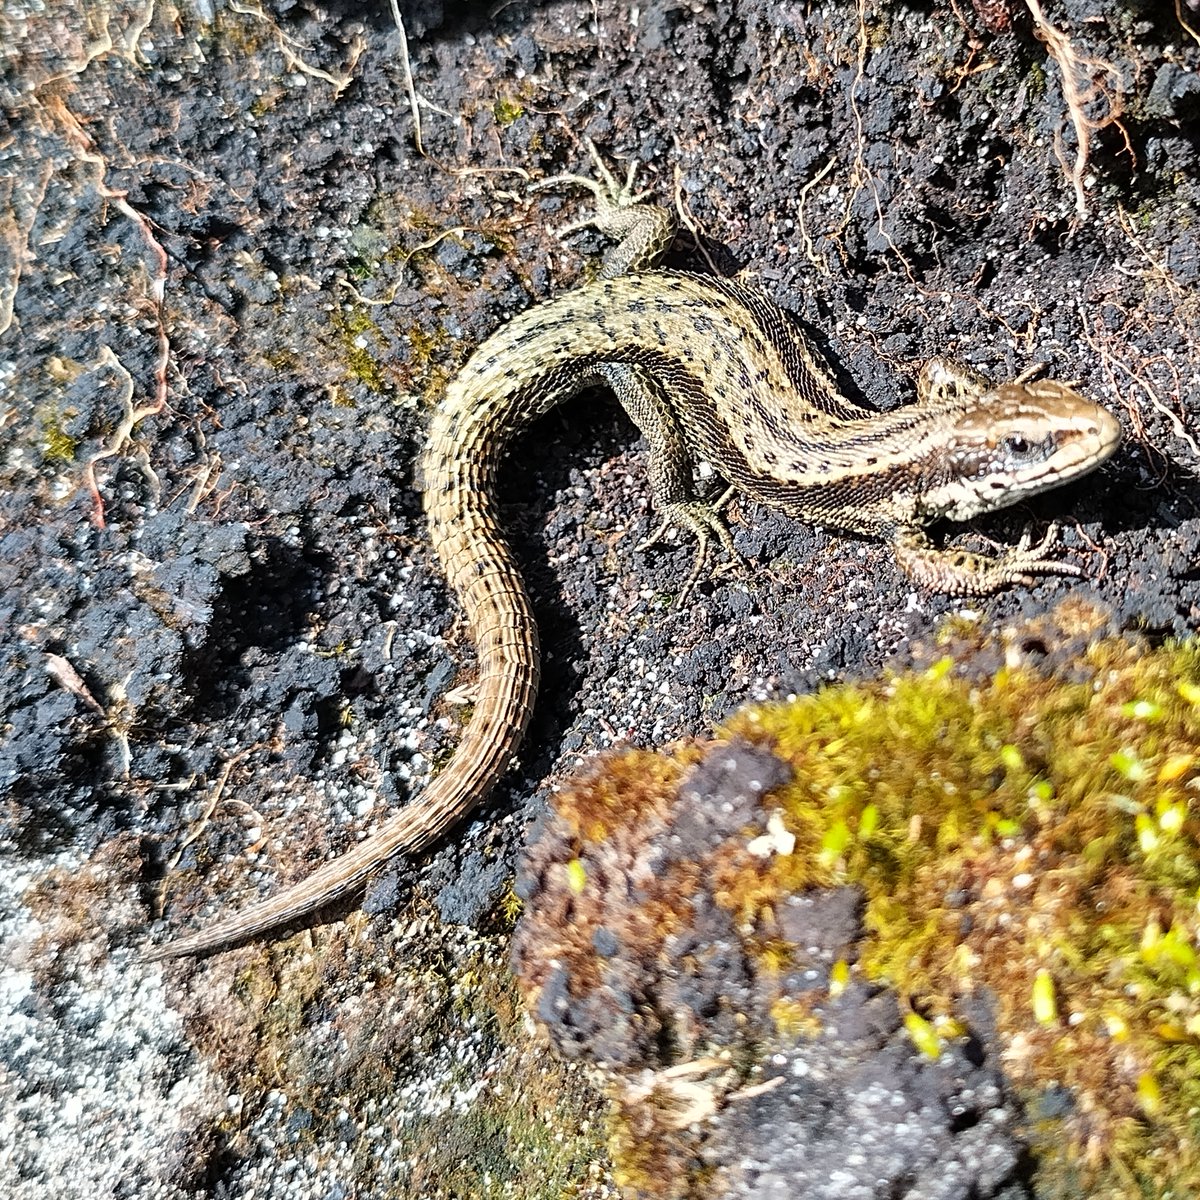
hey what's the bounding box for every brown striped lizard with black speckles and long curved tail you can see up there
[146,144,1121,959]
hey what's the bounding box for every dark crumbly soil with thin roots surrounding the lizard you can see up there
[0,0,1200,1196]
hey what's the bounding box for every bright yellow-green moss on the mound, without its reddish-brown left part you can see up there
[710,640,1200,1194]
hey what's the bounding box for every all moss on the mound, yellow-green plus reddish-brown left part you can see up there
[518,602,1200,1196]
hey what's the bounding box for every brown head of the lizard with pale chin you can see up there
[924,379,1121,521]
